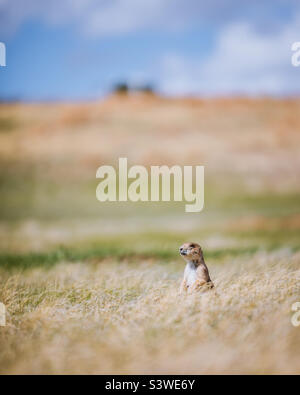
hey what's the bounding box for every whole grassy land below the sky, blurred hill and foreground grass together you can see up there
[0,95,300,374]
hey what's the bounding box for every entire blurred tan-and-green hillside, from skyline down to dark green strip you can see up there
[0,93,300,255]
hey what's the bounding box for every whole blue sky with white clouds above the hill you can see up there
[0,0,300,100]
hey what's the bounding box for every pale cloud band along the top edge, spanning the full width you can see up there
[0,0,299,36]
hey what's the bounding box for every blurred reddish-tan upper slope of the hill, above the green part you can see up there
[0,93,300,190]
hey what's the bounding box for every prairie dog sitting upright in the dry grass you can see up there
[179,243,214,293]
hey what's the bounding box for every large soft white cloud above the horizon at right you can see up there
[160,16,300,95]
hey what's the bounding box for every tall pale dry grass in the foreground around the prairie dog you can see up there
[0,251,300,374]
